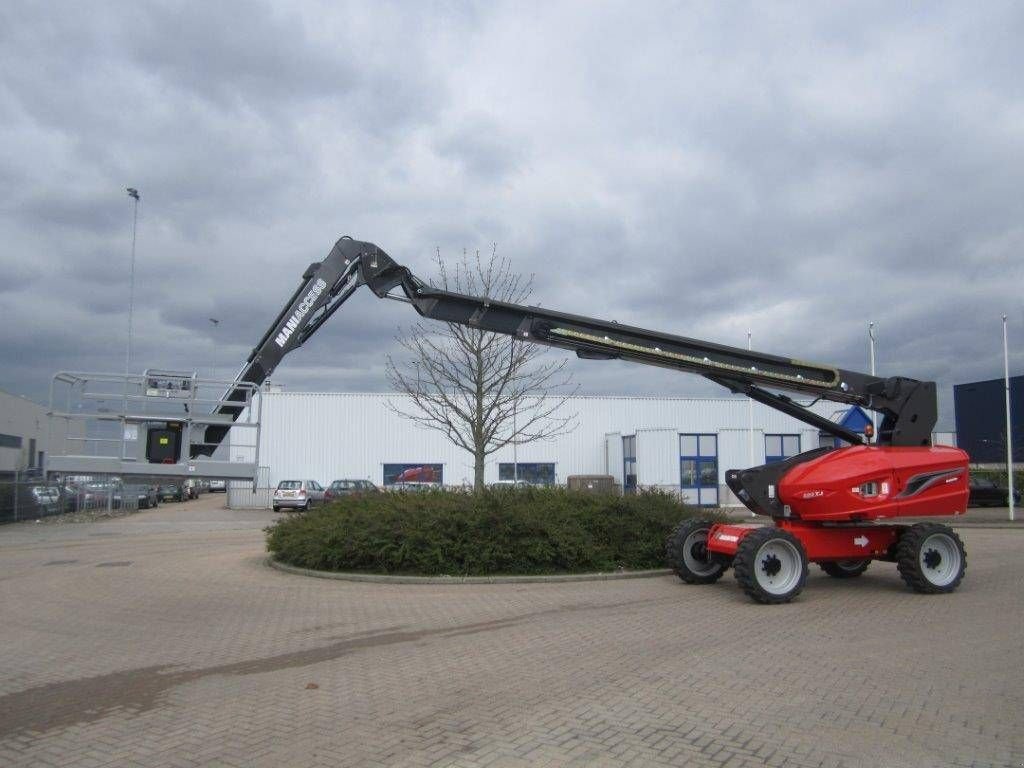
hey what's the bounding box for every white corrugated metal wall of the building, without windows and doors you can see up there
[247,392,856,493]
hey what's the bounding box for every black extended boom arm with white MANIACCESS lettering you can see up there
[193,238,938,455]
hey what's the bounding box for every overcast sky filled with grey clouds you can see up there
[0,0,1024,427]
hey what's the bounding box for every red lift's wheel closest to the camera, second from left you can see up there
[732,527,807,605]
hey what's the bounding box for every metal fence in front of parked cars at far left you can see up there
[0,475,146,523]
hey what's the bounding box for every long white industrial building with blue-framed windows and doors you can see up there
[230,391,952,512]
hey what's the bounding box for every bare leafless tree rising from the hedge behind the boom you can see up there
[387,247,577,490]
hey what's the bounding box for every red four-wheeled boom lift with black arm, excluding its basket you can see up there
[191,237,968,603]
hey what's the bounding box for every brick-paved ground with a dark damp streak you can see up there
[0,497,1024,768]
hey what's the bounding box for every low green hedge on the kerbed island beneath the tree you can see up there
[266,488,702,575]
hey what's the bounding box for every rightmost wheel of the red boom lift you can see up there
[896,522,967,595]
